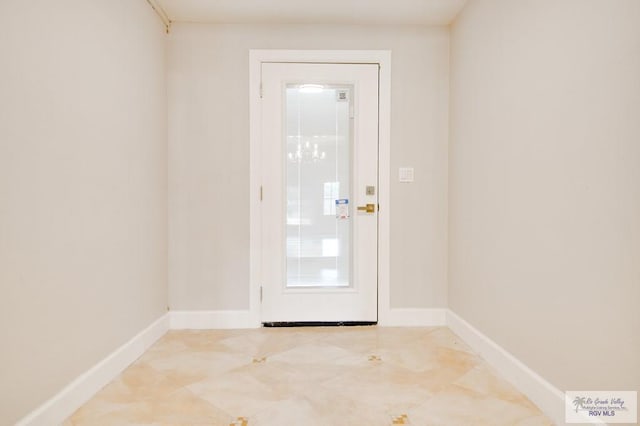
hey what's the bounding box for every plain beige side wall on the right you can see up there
[449,0,640,390]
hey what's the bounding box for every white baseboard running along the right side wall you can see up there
[446,309,565,425]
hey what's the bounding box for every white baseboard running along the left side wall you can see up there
[16,314,169,426]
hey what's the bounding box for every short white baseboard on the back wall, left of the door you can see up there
[169,310,260,330]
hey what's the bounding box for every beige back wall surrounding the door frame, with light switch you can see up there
[168,24,449,310]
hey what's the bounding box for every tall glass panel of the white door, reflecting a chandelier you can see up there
[285,84,353,288]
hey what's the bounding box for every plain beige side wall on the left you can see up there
[0,0,167,425]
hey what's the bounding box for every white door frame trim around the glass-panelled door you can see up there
[249,50,391,327]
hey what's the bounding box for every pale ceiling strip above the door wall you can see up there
[156,0,467,25]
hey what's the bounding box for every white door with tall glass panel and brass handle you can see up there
[261,63,378,323]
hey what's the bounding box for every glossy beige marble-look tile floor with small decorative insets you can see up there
[64,327,552,426]
